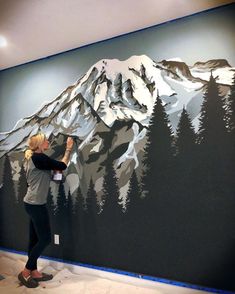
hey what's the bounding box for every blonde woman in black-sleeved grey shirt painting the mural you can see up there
[18,133,73,288]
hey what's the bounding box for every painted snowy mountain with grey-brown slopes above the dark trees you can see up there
[0,55,234,207]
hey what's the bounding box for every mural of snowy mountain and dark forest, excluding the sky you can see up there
[0,51,235,292]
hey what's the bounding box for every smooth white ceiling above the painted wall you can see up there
[0,0,234,70]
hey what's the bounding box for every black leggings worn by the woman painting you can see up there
[24,203,51,271]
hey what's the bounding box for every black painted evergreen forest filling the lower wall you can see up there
[0,76,235,290]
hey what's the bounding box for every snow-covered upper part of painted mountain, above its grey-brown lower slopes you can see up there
[0,55,234,157]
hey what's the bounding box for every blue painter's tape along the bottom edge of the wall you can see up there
[0,247,234,294]
